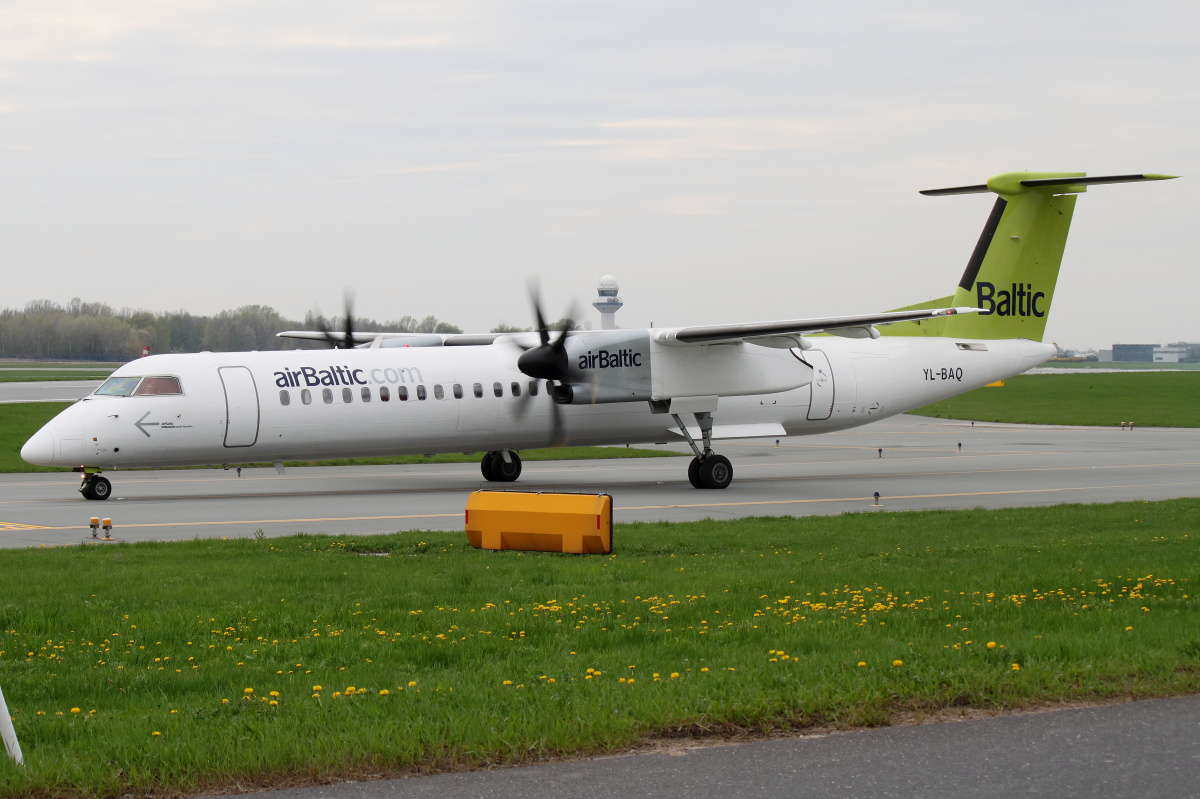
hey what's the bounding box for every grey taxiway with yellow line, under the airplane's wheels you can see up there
[0,416,1200,547]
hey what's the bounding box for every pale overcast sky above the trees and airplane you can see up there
[0,0,1200,347]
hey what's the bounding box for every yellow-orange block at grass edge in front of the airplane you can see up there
[466,491,612,554]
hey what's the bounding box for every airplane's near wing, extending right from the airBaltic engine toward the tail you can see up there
[654,308,983,347]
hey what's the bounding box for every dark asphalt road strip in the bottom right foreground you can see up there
[216,697,1200,799]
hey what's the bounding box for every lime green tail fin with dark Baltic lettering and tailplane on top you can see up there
[881,172,1174,341]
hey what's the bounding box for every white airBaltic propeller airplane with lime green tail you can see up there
[20,172,1174,500]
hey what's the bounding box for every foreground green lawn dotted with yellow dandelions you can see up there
[0,499,1200,797]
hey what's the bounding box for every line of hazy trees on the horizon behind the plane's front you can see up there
[0,298,462,361]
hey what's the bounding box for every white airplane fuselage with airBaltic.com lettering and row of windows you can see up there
[22,337,1054,469]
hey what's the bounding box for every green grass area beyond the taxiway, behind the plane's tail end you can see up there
[911,372,1200,427]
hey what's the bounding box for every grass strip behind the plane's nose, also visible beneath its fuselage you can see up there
[0,402,680,471]
